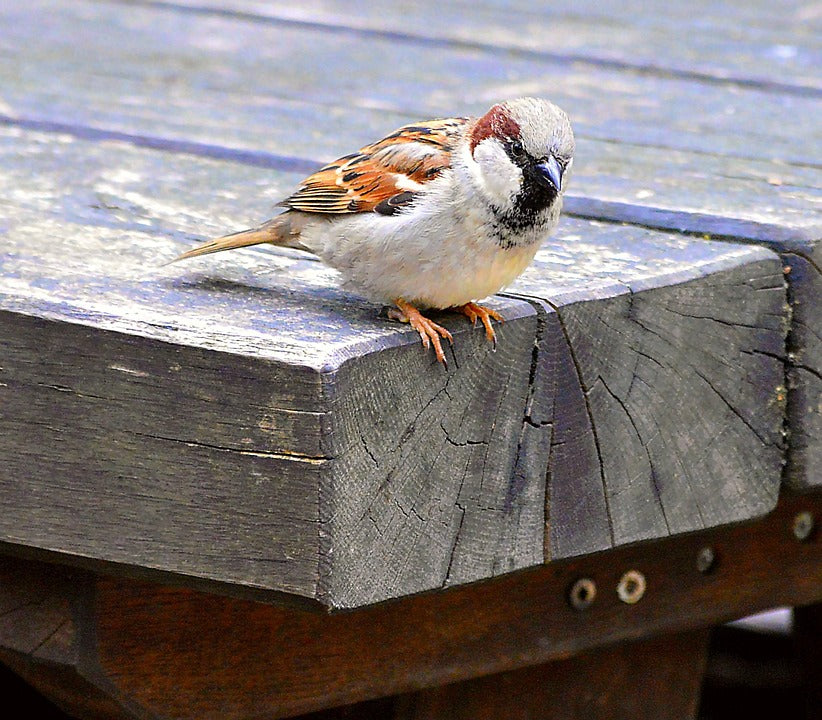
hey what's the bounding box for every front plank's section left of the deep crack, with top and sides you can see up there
[0,131,544,606]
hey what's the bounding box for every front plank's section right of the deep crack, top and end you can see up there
[511,221,786,557]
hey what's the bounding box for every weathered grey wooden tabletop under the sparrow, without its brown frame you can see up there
[0,0,822,609]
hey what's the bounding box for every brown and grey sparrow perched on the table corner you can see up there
[177,97,574,364]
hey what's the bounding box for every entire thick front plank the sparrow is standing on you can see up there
[0,128,784,607]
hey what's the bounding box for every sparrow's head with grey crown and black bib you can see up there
[468,97,574,213]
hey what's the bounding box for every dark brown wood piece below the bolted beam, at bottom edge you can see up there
[395,630,709,720]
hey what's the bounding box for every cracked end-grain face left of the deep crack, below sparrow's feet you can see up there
[320,304,545,607]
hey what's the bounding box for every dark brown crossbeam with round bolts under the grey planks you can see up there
[3,493,822,720]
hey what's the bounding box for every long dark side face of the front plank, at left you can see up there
[0,312,327,597]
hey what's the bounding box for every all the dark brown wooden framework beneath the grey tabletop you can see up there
[0,494,822,720]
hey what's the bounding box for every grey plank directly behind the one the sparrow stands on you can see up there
[3,3,822,496]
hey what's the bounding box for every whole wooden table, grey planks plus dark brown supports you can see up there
[0,0,822,720]
